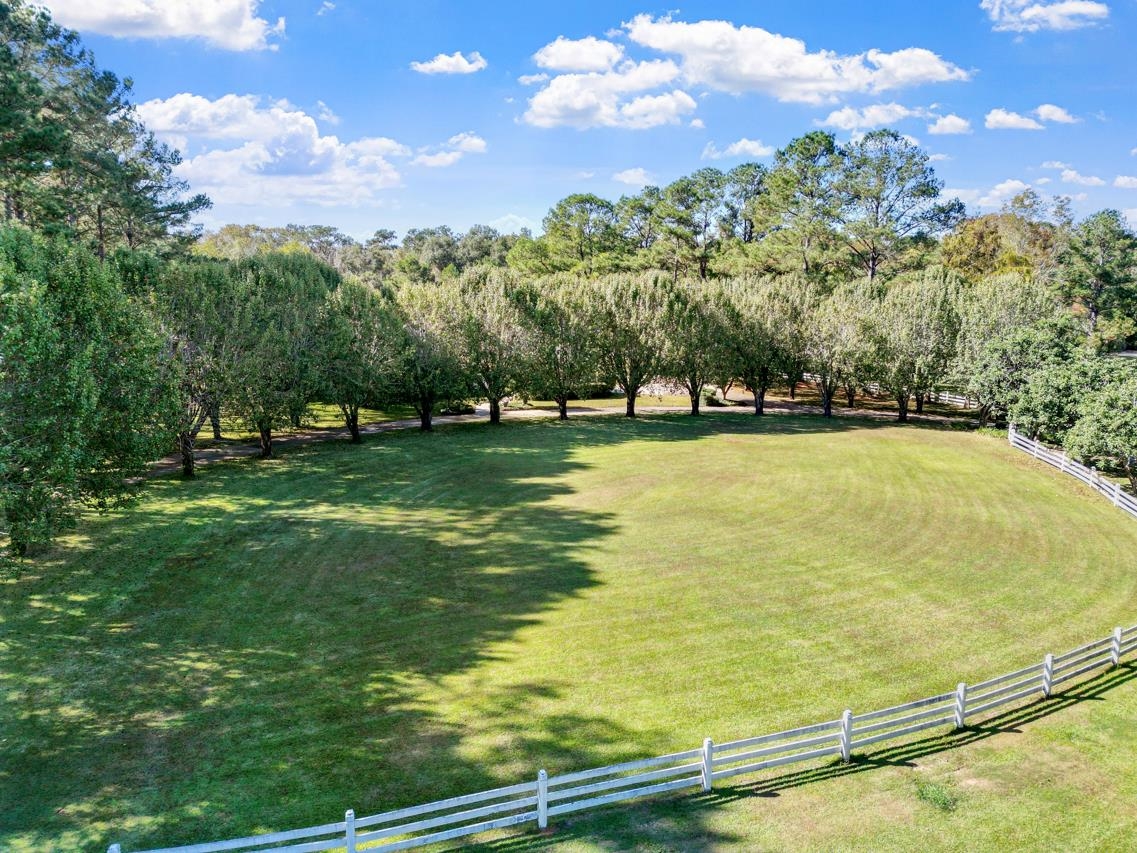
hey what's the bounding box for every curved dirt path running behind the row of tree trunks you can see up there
[150,400,973,475]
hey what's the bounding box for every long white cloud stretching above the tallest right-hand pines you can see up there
[624,15,971,103]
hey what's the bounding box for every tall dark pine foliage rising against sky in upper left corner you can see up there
[0,0,209,257]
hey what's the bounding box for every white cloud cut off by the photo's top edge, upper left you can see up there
[40,0,284,50]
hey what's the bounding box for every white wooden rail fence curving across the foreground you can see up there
[108,626,1137,853]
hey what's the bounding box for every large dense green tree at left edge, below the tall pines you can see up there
[0,229,177,554]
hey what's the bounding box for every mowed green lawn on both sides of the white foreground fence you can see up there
[0,413,1137,851]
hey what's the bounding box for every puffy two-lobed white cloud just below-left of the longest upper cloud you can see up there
[524,59,696,130]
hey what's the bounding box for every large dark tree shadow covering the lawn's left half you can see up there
[0,415,991,850]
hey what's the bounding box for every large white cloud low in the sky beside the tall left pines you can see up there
[139,93,487,207]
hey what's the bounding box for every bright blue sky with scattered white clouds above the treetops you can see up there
[35,0,1137,238]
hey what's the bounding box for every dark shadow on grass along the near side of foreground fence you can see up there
[461,661,1137,853]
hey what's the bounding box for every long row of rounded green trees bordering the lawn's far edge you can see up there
[0,217,1137,552]
